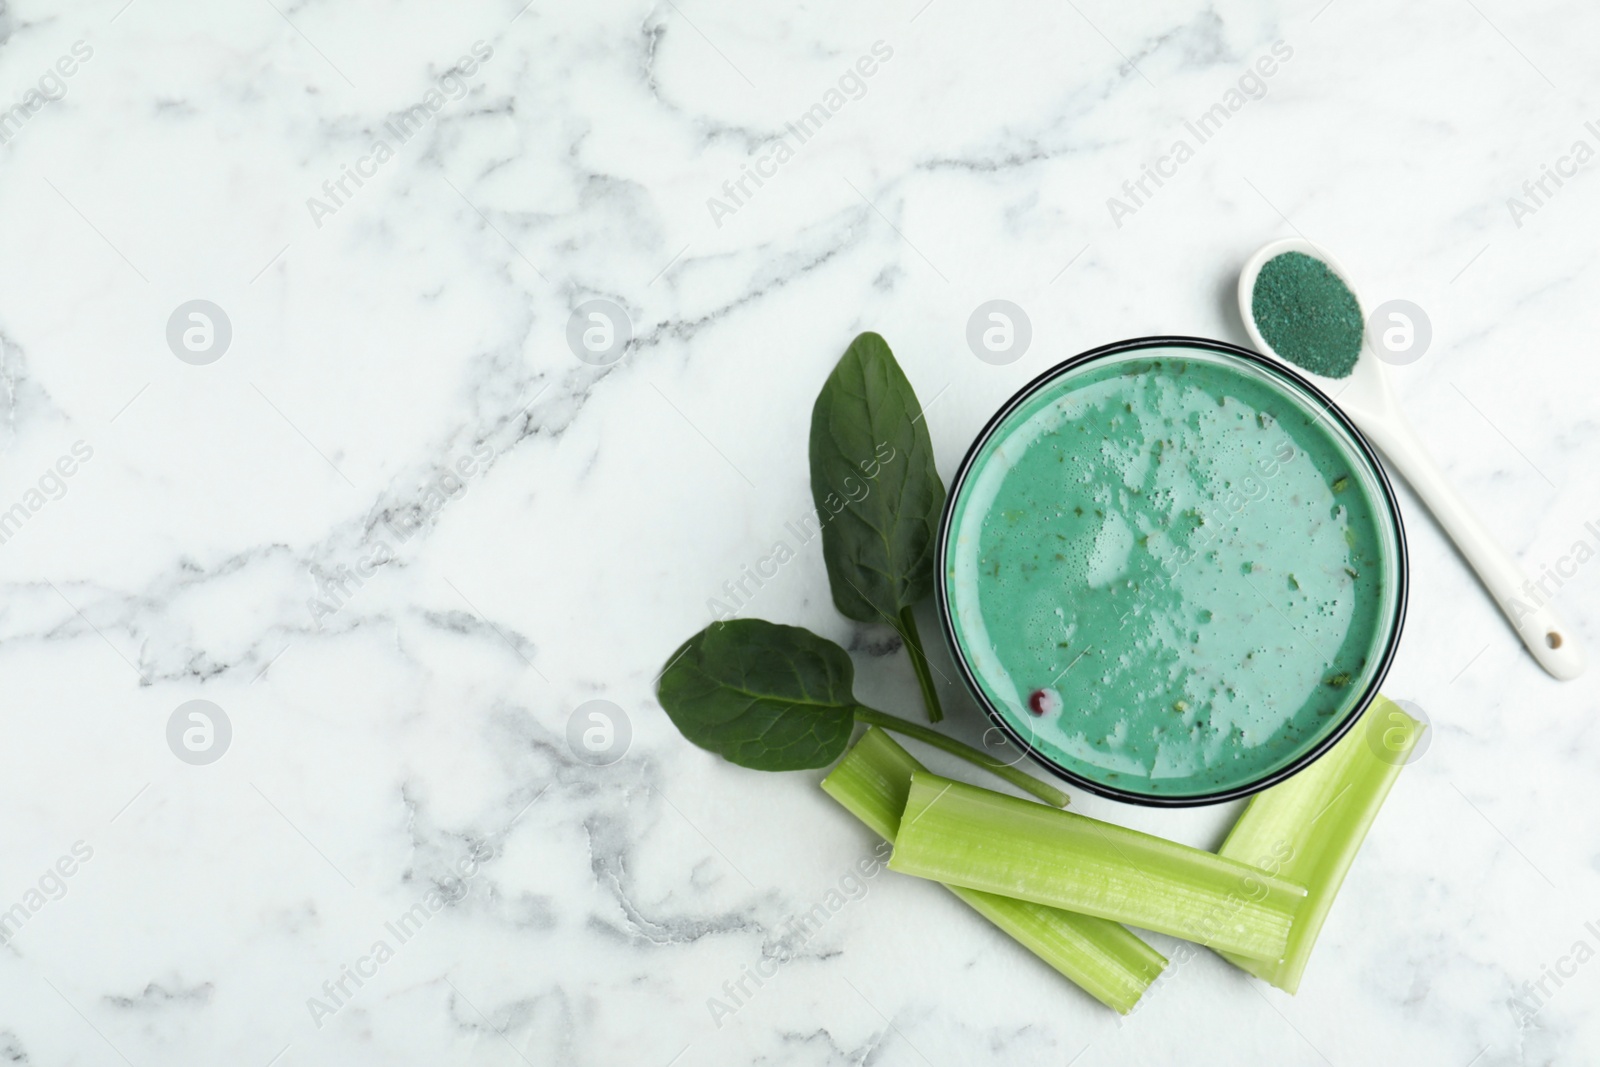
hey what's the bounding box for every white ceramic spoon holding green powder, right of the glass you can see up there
[1238,237,1586,681]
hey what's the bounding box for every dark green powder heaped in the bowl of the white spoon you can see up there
[1250,251,1363,378]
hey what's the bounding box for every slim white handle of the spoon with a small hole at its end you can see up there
[1362,419,1586,681]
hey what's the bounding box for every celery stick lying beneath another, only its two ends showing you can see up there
[822,726,1166,1014]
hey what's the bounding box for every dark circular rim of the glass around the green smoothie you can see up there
[934,334,1411,808]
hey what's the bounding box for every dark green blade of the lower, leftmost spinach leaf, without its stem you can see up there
[656,619,856,771]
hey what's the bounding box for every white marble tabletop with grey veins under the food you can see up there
[0,0,1600,1067]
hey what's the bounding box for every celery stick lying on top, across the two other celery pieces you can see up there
[890,771,1306,960]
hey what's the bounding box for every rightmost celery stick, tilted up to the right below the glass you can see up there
[1219,696,1426,993]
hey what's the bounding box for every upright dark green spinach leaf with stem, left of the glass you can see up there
[811,333,944,721]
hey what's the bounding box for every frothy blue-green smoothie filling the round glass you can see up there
[944,349,1398,797]
